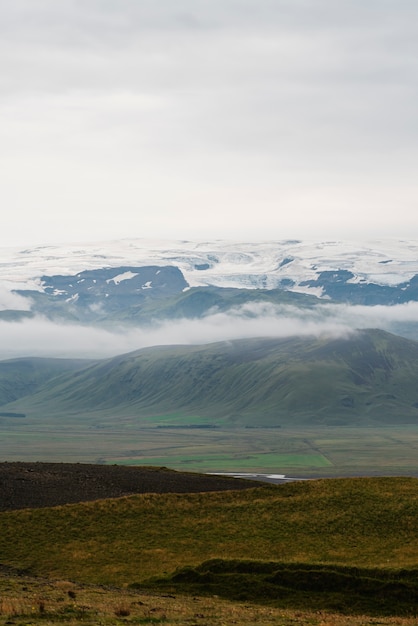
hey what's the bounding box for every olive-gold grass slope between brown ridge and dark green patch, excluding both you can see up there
[0,478,418,584]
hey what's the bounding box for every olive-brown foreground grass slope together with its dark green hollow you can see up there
[0,478,418,623]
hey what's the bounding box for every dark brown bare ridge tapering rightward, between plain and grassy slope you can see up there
[0,462,255,511]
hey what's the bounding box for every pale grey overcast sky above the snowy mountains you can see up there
[0,0,418,245]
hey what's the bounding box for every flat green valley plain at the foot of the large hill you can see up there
[0,422,418,478]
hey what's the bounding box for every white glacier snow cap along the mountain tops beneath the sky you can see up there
[0,239,418,295]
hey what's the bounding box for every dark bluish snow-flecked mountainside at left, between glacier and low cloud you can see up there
[14,282,320,326]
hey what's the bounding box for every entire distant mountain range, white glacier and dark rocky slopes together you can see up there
[0,239,418,324]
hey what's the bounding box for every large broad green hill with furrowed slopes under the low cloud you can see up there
[6,330,418,427]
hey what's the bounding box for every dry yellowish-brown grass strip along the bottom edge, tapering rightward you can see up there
[0,575,416,626]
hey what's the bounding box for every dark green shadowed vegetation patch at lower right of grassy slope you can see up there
[141,559,418,617]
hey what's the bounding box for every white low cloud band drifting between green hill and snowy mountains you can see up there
[0,302,418,359]
